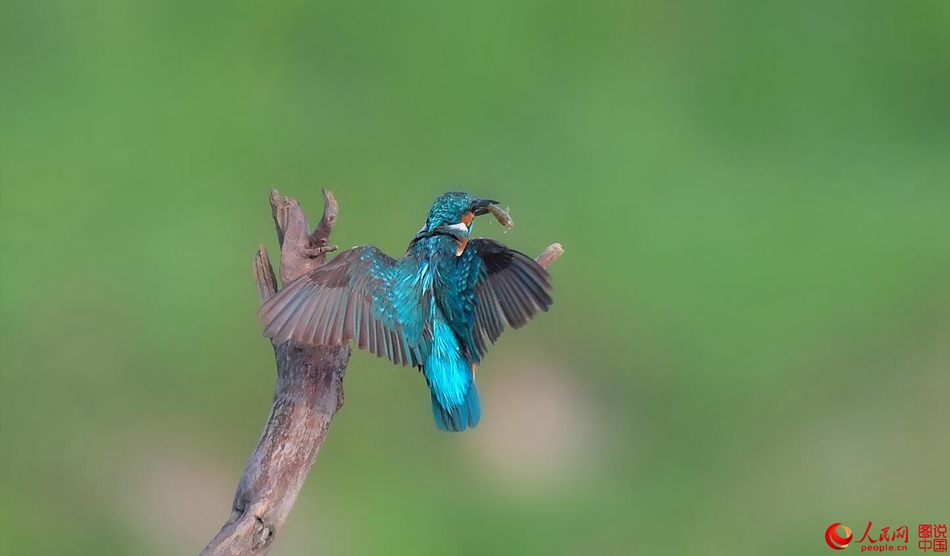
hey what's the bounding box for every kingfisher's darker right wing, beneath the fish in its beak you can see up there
[466,239,554,355]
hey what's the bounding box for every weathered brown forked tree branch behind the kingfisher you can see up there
[201,190,564,556]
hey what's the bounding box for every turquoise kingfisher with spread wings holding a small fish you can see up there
[258,192,553,432]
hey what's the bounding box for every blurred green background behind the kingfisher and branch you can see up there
[0,0,950,556]
